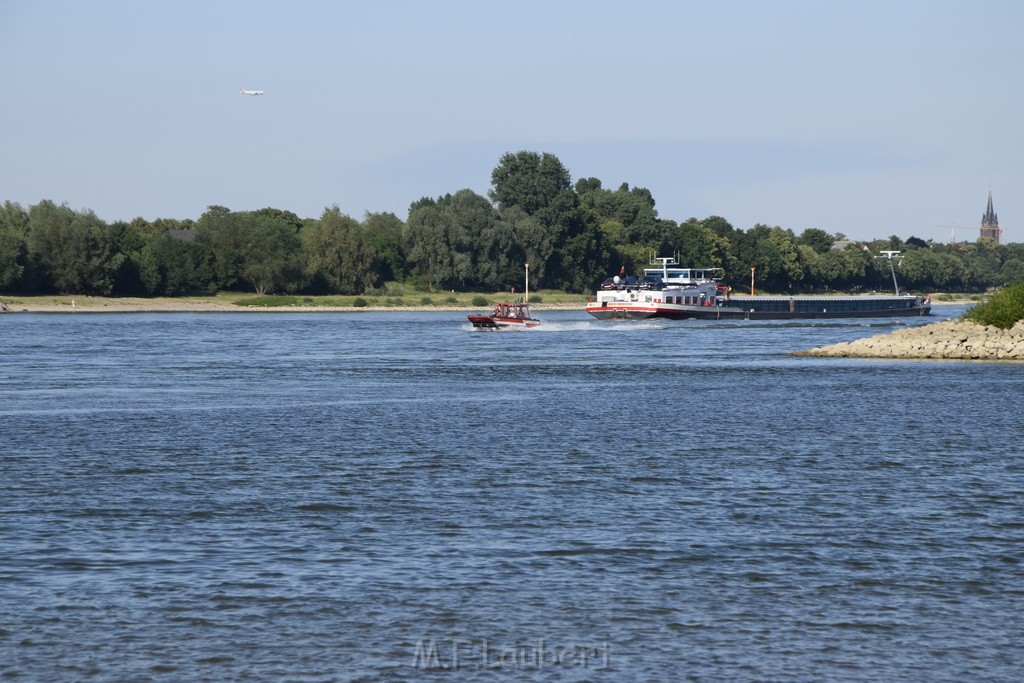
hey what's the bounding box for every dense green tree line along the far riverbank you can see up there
[0,152,1024,296]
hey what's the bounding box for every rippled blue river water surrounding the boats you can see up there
[0,305,1024,681]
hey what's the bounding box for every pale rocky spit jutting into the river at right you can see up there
[794,319,1024,360]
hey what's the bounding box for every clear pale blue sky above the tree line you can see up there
[0,0,1024,242]
